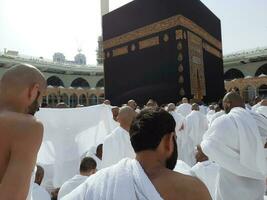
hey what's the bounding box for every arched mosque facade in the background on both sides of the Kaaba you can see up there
[0,46,267,107]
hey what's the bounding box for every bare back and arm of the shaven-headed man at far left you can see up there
[0,111,43,199]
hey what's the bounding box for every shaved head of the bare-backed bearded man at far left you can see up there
[0,64,46,115]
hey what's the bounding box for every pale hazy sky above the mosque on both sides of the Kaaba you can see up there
[0,0,267,64]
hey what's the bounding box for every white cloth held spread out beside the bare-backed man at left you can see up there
[36,104,113,188]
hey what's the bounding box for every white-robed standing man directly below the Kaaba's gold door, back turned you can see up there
[183,104,208,167]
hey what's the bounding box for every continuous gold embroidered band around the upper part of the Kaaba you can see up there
[103,15,222,50]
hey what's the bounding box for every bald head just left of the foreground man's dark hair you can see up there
[117,106,136,130]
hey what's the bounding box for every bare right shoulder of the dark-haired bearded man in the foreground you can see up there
[159,170,211,200]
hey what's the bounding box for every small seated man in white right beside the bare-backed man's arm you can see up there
[32,165,51,200]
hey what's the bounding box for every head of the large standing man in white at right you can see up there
[223,92,245,113]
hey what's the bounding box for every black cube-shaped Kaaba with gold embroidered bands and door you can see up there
[102,0,224,105]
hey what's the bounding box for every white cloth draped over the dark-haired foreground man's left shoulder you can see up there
[63,158,163,200]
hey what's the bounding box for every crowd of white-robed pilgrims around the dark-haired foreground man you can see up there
[32,92,267,200]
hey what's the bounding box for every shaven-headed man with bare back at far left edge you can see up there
[0,64,46,200]
